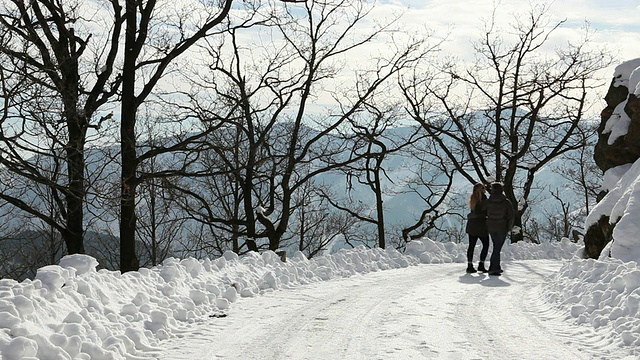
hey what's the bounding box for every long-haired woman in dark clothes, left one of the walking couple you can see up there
[466,183,489,273]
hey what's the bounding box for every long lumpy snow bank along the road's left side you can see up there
[0,249,418,360]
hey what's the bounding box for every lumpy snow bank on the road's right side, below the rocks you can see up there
[543,259,640,346]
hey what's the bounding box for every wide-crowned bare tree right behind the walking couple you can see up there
[402,5,610,241]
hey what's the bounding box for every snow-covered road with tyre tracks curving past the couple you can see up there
[159,260,608,360]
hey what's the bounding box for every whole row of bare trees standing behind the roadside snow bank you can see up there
[0,0,612,278]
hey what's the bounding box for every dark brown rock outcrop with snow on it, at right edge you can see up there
[584,59,640,258]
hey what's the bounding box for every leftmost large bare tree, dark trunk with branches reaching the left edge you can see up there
[0,0,124,254]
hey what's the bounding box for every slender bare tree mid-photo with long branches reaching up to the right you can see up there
[250,1,432,249]
